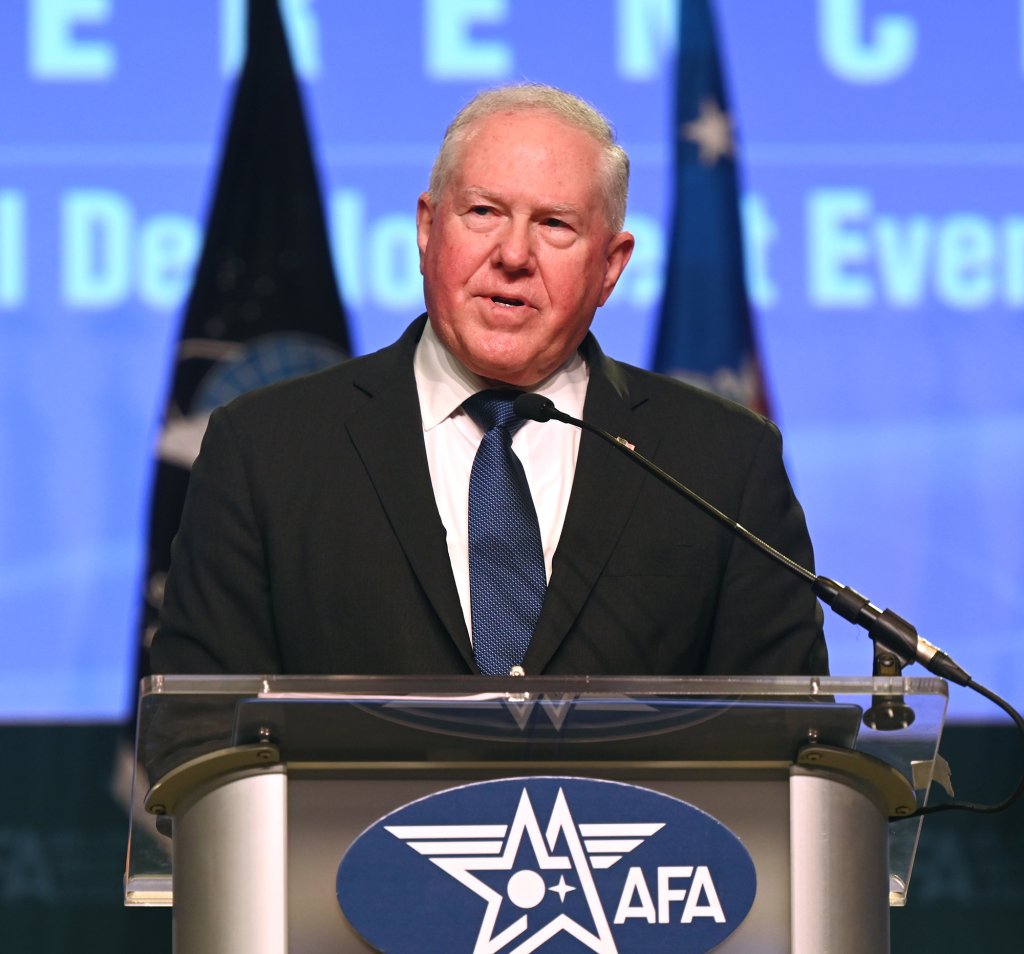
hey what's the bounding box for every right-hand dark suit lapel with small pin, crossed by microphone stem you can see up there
[523,336,659,675]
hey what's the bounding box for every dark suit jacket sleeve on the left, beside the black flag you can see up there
[152,408,281,674]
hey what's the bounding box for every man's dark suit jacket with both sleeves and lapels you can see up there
[153,317,826,675]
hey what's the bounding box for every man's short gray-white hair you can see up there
[429,83,630,232]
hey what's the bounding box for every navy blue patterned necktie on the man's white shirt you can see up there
[463,390,547,676]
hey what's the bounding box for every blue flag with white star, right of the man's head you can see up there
[653,0,768,414]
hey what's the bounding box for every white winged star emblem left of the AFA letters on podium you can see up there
[385,788,665,954]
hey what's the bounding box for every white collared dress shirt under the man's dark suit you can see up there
[413,321,590,638]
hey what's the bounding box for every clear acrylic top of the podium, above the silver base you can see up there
[126,675,947,904]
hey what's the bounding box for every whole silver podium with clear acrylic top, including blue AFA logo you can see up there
[126,677,946,954]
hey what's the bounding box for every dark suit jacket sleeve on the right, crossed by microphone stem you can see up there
[707,423,828,675]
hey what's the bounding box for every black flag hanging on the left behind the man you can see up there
[136,0,349,686]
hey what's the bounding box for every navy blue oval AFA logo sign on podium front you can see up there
[337,778,757,954]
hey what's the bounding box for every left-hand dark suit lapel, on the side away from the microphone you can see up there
[347,318,475,671]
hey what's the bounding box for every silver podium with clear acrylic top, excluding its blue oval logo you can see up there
[125,676,947,954]
